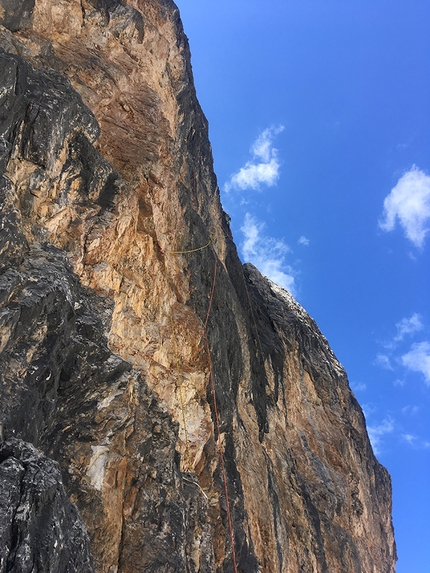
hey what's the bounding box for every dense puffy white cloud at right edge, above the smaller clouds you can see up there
[379,165,430,247]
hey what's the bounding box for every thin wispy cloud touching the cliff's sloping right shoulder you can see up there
[241,213,295,294]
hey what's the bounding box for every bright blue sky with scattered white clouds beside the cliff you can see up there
[177,0,430,573]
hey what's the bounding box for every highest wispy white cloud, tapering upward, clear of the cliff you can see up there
[224,125,284,192]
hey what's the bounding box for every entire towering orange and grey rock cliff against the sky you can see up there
[0,0,396,573]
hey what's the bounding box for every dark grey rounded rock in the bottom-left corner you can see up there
[0,439,94,573]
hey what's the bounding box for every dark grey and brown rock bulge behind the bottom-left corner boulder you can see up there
[0,177,213,572]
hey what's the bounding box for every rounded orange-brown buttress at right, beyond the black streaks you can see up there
[241,265,395,572]
